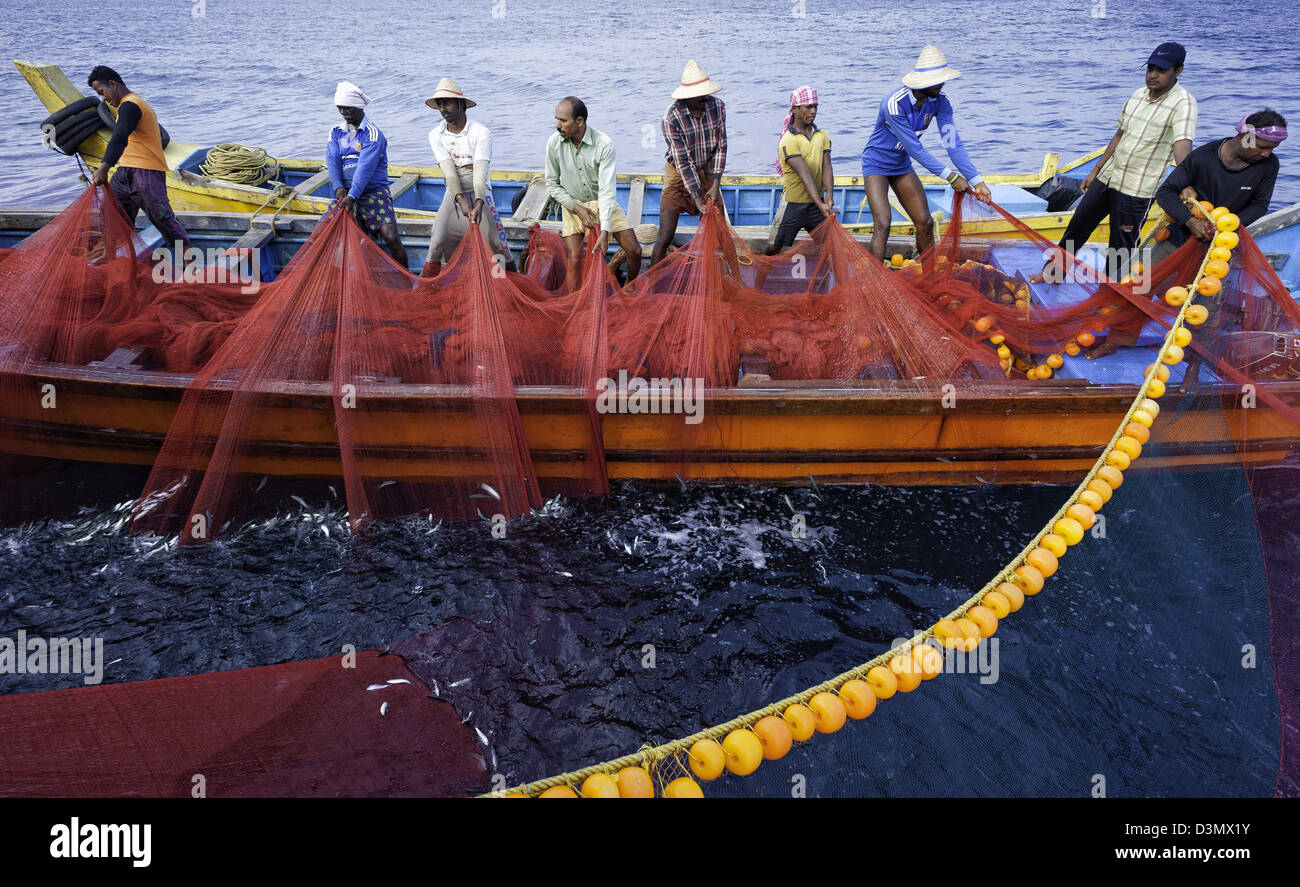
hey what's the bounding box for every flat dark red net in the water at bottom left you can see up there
[0,652,488,797]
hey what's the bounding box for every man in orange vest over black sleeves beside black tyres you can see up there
[87,65,190,252]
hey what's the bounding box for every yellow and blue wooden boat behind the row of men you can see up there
[13,61,1138,255]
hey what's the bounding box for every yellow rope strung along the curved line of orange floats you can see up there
[481,227,1227,797]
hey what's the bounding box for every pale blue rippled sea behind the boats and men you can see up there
[0,0,1300,205]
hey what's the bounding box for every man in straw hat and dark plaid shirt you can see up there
[650,60,727,264]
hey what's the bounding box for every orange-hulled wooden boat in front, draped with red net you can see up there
[0,204,1300,484]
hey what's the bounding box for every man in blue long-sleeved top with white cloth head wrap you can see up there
[325,81,407,268]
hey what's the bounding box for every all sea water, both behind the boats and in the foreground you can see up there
[0,0,1300,796]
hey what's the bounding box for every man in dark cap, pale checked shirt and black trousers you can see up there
[1030,43,1196,284]
